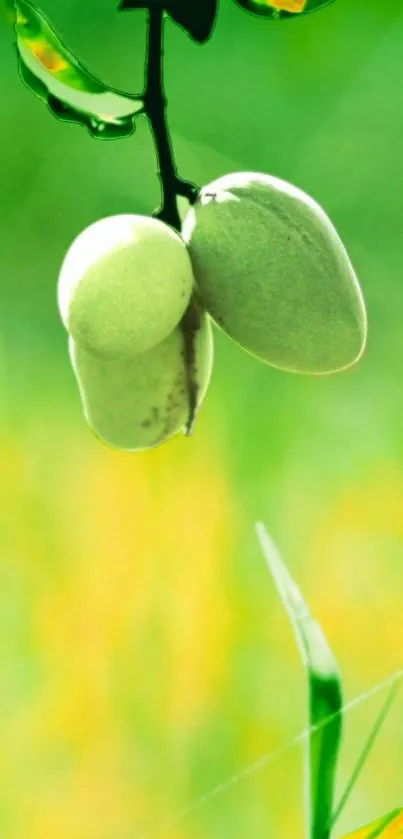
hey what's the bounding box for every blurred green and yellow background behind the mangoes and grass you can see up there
[0,0,403,839]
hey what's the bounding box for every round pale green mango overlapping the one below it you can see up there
[58,214,193,360]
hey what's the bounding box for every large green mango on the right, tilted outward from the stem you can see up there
[182,172,367,375]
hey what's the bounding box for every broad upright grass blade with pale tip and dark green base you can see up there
[256,523,342,839]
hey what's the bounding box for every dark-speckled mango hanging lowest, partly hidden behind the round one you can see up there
[69,313,213,451]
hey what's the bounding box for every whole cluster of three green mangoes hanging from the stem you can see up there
[58,167,367,450]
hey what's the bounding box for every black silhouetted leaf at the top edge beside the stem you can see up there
[119,0,218,44]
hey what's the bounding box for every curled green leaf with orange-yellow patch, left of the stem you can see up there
[13,0,142,139]
